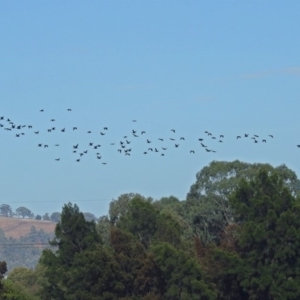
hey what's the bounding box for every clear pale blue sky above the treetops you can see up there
[0,0,300,217]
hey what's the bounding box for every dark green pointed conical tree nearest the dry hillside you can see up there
[41,203,117,300]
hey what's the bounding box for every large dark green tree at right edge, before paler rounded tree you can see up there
[216,169,300,299]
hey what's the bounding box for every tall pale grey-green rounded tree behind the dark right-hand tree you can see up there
[183,160,300,243]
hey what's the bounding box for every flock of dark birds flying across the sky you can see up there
[0,108,278,165]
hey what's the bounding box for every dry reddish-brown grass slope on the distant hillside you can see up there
[0,217,56,238]
